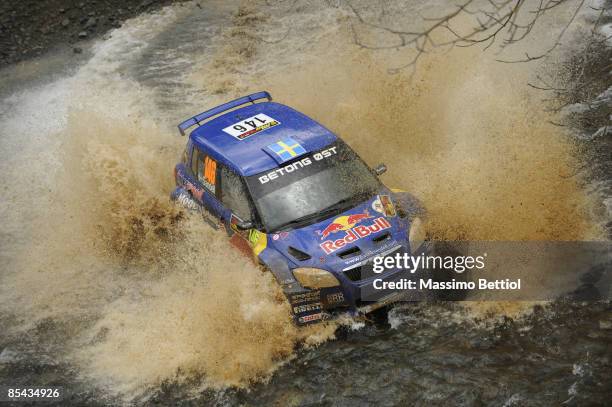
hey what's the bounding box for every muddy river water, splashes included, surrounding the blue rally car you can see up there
[0,1,612,406]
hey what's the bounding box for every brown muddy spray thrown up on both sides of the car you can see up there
[0,0,601,402]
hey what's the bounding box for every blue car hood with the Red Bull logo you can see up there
[268,189,408,271]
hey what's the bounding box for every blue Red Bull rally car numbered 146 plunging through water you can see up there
[172,92,428,325]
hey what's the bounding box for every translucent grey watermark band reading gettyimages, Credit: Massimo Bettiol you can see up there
[358,241,612,301]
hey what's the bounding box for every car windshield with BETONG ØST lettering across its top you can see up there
[247,142,380,232]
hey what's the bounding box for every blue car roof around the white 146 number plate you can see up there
[189,102,337,176]
